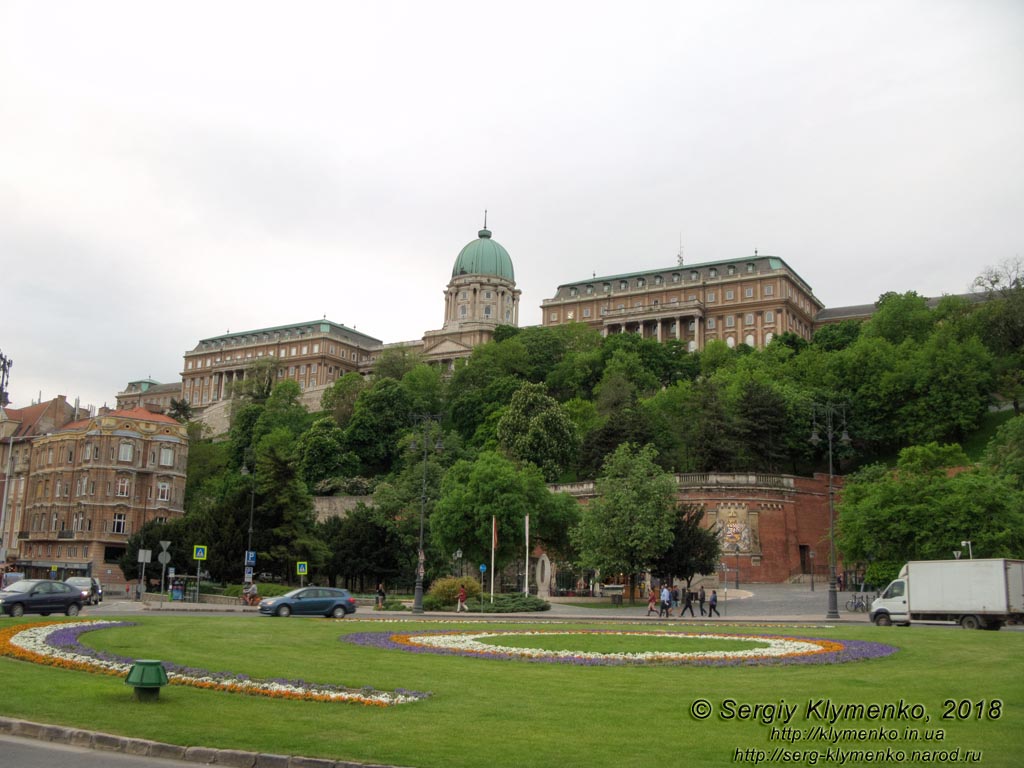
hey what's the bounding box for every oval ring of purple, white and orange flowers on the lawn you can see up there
[342,630,898,667]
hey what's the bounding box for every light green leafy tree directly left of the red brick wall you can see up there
[570,443,677,594]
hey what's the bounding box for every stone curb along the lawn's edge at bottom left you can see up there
[0,716,407,768]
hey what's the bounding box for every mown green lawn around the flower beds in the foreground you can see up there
[0,615,1024,768]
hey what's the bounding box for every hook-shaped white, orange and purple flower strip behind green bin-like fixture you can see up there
[0,622,430,707]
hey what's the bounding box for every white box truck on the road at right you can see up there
[868,559,1024,630]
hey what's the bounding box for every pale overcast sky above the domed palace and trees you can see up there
[0,0,1024,415]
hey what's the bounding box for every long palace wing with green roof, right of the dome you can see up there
[541,252,823,351]
